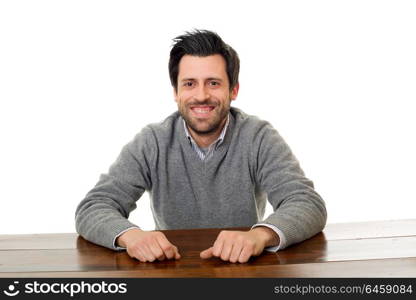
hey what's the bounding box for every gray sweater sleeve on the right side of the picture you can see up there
[252,122,327,250]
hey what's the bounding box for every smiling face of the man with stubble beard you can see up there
[175,54,238,135]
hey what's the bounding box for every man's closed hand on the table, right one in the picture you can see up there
[200,226,279,263]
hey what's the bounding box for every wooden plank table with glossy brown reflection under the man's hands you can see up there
[0,220,416,278]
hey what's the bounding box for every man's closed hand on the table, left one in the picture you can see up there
[116,228,181,262]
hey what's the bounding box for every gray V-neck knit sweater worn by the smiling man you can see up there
[76,107,326,249]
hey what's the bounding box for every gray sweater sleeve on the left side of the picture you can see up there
[75,127,156,250]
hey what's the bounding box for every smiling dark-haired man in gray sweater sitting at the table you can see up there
[76,30,326,263]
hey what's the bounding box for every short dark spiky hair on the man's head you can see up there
[169,29,240,91]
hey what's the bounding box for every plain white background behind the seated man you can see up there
[0,0,416,234]
